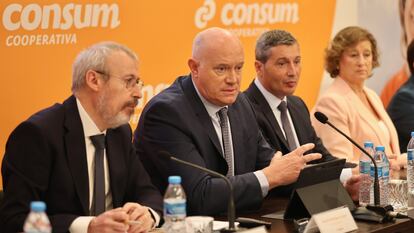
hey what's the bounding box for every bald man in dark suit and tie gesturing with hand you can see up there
[134,28,321,215]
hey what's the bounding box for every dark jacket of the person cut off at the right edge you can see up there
[387,76,414,153]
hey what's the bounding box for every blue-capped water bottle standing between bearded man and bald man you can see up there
[163,176,187,233]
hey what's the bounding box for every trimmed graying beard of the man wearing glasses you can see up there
[97,89,138,128]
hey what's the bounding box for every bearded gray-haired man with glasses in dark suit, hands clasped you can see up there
[0,42,162,233]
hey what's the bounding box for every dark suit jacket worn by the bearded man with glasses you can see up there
[0,96,162,232]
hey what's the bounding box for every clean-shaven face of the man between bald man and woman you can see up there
[255,43,301,99]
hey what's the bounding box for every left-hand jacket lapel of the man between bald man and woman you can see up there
[248,82,289,148]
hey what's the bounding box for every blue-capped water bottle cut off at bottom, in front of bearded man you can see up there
[23,201,52,233]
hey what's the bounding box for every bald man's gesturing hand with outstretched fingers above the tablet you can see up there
[263,143,322,189]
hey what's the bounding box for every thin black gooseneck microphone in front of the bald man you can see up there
[158,151,236,232]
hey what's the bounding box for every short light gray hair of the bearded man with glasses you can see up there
[72,41,138,94]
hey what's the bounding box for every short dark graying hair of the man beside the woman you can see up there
[256,30,297,63]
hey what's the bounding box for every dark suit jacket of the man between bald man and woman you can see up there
[244,82,335,163]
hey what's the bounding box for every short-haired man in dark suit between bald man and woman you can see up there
[244,30,359,199]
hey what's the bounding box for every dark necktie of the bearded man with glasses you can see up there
[90,134,105,216]
